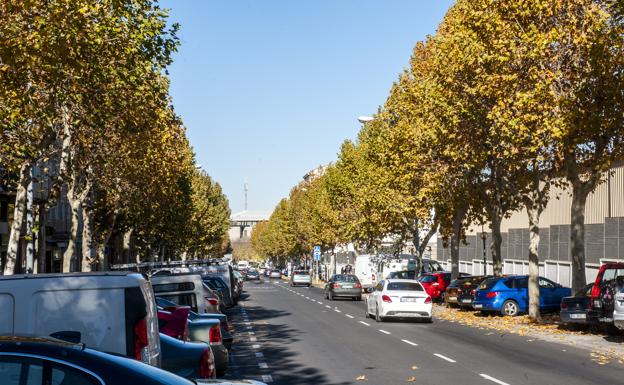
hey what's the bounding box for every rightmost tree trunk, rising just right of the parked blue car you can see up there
[570,183,589,293]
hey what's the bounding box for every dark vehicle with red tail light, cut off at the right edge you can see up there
[587,263,624,323]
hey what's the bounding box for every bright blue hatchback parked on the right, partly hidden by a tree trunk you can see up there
[472,275,571,316]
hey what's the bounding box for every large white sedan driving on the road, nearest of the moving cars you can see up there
[366,279,432,322]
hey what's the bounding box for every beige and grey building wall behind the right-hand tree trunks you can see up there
[437,164,624,285]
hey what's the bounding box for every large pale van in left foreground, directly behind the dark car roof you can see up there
[0,272,161,367]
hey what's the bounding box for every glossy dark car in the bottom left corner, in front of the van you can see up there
[0,336,199,385]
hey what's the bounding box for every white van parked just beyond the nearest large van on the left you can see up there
[150,273,207,313]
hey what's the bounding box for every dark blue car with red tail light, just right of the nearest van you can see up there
[160,333,217,380]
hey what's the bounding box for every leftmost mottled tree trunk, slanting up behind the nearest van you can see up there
[4,162,32,275]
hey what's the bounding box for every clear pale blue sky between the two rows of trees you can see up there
[161,0,452,212]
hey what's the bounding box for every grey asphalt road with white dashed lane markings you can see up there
[228,280,624,385]
